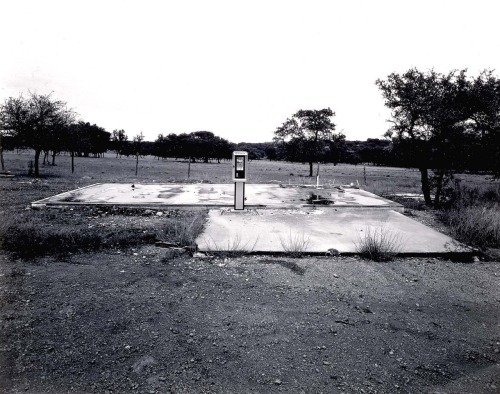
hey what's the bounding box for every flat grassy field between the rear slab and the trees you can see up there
[1,152,499,203]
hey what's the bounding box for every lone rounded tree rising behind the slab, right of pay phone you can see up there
[274,108,335,176]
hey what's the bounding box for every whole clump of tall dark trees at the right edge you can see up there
[376,69,500,206]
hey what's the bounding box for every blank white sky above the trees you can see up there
[0,0,500,142]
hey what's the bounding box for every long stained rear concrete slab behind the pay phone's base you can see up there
[32,183,403,211]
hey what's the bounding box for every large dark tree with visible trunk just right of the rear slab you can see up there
[376,69,473,205]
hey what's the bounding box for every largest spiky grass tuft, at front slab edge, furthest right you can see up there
[355,227,402,261]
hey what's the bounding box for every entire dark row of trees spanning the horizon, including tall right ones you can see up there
[0,68,500,205]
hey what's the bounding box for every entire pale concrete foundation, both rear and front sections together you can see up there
[32,183,468,254]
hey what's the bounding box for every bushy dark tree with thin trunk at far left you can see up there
[0,92,74,176]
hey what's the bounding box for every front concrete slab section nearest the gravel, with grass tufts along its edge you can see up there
[196,207,468,254]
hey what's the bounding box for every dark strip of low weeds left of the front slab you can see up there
[0,211,204,258]
